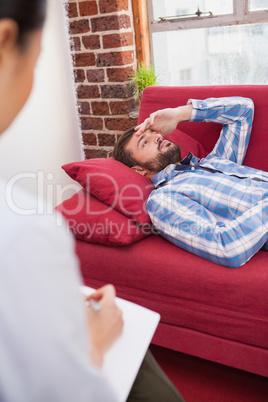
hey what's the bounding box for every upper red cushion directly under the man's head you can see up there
[62,158,154,225]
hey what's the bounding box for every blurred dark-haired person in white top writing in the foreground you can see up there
[0,0,182,402]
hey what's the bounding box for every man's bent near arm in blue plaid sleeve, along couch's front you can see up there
[147,190,268,268]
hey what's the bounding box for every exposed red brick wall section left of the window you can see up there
[68,0,137,158]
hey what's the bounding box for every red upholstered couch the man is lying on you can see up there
[76,86,268,377]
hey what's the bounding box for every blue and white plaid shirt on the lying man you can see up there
[147,97,268,268]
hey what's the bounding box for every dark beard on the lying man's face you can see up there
[139,141,181,174]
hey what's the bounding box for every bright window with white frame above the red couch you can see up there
[148,0,268,85]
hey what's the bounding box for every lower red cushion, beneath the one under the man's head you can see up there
[56,189,151,246]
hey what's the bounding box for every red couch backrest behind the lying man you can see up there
[139,85,268,171]
